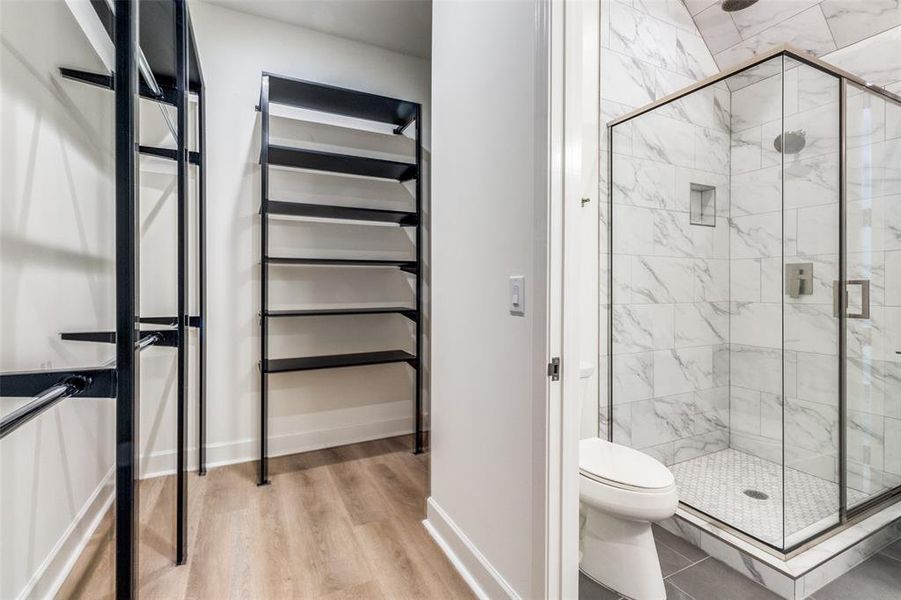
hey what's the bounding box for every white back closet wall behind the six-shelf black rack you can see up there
[142,2,429,474]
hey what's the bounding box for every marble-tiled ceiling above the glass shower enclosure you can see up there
[683,0,901,69]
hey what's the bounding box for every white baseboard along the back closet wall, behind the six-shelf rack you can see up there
[141,417,413,479]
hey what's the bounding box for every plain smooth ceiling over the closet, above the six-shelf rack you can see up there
[205,0,432,58]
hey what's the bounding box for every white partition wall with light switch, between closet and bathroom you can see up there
[428,1,548,598]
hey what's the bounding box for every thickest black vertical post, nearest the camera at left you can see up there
[113,0,140,600]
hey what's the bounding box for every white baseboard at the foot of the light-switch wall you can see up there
[422,497,519,600]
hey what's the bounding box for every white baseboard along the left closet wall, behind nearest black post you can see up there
[18,467,116,600]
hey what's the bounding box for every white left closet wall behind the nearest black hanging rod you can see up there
[0,0,115,598]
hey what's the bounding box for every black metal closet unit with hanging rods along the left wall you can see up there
[0,0,206,599]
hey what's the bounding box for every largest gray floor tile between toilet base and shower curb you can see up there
[669,558,779,600]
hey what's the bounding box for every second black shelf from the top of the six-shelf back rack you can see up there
[268,144,417,181]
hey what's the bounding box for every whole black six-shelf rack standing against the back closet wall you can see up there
[257,73,423,485]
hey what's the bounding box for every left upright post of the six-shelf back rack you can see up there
[257,75,269,485]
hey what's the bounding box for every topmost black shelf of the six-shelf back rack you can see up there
[263,73,419,129]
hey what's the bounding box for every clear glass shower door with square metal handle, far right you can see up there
[844,82,901,510]
